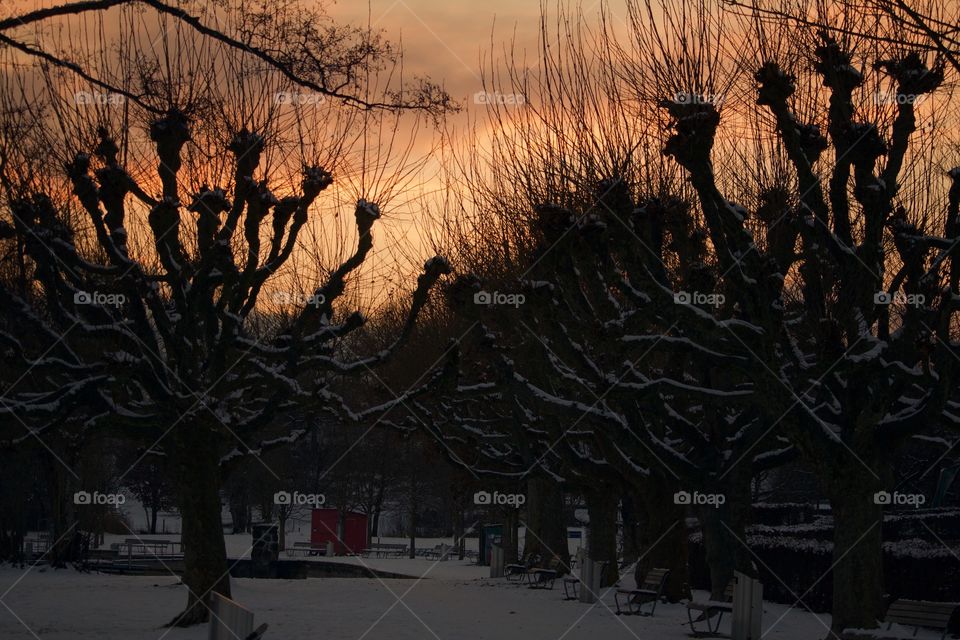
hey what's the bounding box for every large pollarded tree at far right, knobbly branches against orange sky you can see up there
[638,3,960,633]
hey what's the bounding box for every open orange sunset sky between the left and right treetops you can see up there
[0,0,956,304]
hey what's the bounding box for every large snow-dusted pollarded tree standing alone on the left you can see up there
[0,2,447,625]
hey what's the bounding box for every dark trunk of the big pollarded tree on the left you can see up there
[170,424,230,627]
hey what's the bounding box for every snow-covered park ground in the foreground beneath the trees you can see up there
[0,559,829,640]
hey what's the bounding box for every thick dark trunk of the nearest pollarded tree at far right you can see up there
[830,470,883,635]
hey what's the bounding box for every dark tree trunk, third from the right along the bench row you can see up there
[634,474,690,602]
